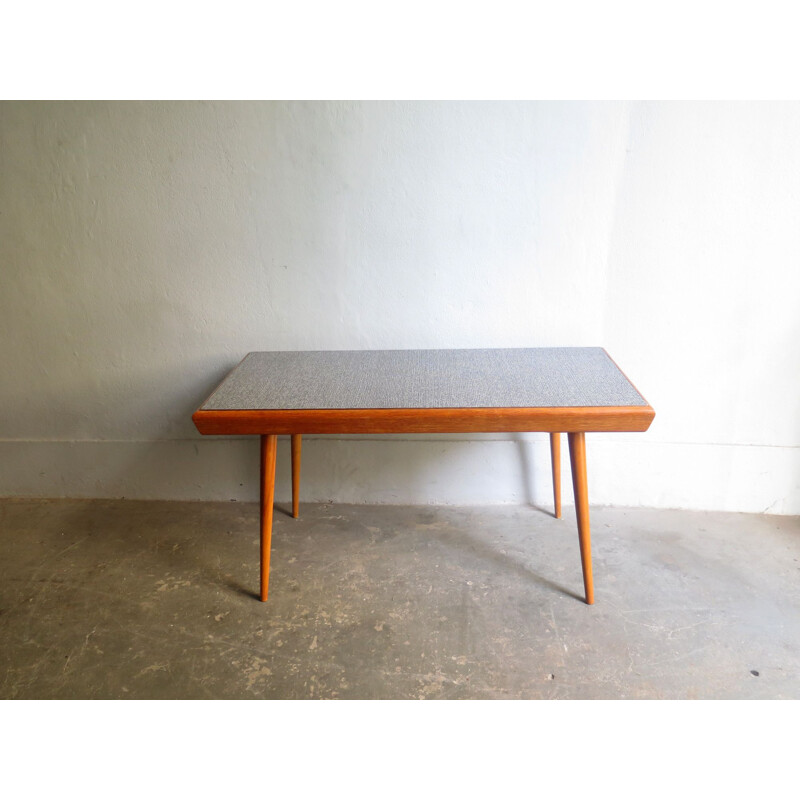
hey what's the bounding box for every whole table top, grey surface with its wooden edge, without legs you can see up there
[192,347,655,434]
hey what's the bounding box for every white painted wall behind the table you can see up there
[0,102,800,514]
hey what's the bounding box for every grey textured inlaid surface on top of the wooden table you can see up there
[201,347,647,411]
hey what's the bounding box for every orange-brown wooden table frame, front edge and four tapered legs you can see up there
[192,405,655,605]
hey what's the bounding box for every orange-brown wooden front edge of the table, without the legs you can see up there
[192,406,655,435]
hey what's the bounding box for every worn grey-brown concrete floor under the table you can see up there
[0,500,800,699]
